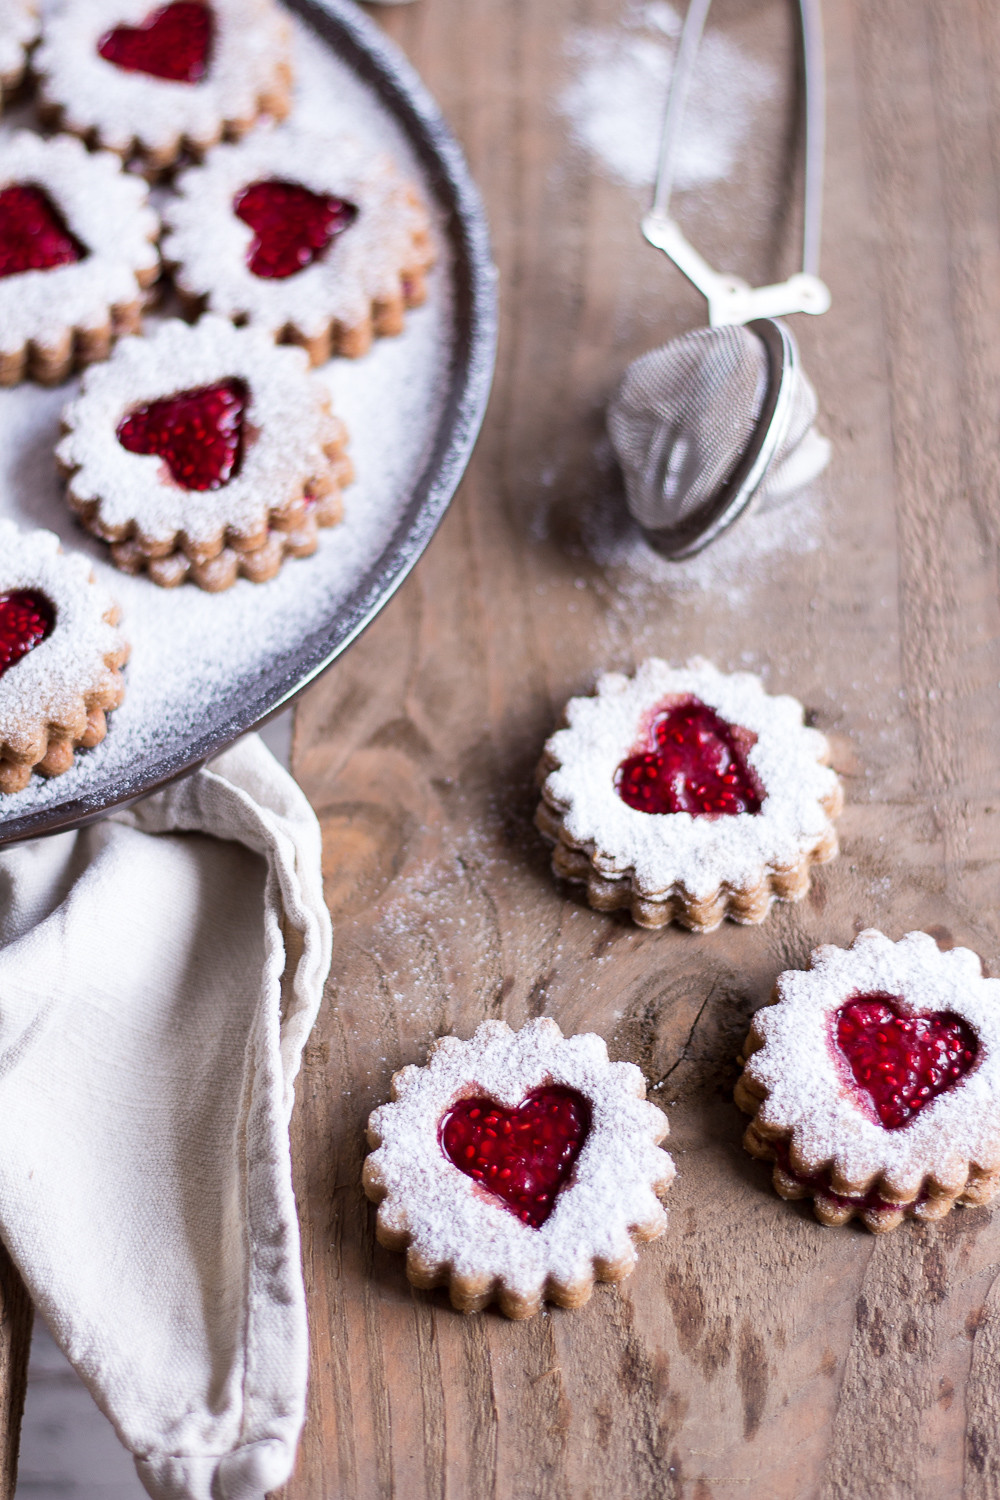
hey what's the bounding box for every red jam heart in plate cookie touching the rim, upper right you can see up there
[232,179,358,281]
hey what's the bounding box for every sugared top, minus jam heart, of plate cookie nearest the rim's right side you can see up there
[163,126,427,338]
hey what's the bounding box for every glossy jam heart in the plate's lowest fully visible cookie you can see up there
[118,380,247,489]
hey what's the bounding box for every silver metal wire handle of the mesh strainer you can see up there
[642,0,831,327]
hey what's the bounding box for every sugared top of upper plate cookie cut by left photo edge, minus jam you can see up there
[0,131,159,354]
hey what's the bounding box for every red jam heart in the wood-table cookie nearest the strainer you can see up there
[615,698,765,818]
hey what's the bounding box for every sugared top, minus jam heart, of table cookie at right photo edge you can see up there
[747,929,1000,1199]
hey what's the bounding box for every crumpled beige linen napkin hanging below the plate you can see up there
[0,738,331,1500]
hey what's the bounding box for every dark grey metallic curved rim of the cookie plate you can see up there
[0,0,499,848]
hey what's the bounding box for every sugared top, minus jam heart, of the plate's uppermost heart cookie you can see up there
[34,0,291,156]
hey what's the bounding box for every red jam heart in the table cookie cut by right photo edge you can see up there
[834,992,979,1130]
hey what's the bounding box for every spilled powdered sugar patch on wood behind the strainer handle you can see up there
[558,0,774,189]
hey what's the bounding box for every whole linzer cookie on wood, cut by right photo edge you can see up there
[736,929,1000,1235]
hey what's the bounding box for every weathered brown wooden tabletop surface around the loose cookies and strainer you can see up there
[271,0,1000,1500]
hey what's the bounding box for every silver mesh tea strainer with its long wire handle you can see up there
[609,0,831,560]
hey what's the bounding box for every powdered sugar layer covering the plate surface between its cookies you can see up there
[0,8,453,830]
